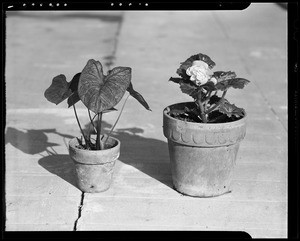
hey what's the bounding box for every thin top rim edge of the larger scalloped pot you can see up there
[163,101,247,127]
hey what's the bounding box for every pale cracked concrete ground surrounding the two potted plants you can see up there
[5,3,287,238]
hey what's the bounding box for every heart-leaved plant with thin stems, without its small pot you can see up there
[44,59,151,150]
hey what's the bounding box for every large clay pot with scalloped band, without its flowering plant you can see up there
[163,102,246,197]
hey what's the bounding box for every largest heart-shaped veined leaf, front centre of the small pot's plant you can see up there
[78,59,131,113]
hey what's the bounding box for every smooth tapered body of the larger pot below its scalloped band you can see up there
[168,140,239,197]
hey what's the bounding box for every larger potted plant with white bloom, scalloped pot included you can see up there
[163,53,250,197]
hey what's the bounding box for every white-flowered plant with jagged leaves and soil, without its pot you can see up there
[169,53,250,123]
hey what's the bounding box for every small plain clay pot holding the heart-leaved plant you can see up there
[69,137,121,193]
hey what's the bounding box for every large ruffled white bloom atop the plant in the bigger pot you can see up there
[186,60,209,86]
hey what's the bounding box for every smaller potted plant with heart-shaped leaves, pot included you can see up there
[44,59,150,192]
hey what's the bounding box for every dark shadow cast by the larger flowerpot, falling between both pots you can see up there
[85,121,173,188]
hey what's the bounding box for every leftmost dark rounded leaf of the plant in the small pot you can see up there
[44,74,72,105]
